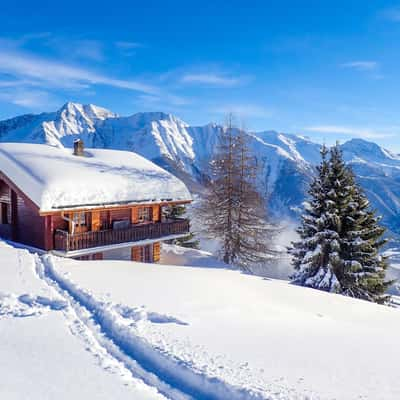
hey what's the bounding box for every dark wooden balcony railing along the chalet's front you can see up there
[54,219,189,251]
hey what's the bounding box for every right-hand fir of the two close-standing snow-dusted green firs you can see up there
[331,145,393,303]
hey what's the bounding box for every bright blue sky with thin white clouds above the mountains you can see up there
[0,0,400,152]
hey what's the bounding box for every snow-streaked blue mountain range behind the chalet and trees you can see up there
[0,103,400,239]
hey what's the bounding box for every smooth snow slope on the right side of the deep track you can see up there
[50,248,400,400]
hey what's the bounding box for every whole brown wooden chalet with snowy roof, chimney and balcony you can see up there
[0,141,191,262]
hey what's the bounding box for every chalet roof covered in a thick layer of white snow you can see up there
[0,143,191,212]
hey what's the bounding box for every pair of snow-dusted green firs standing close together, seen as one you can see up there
[290,145,391,303]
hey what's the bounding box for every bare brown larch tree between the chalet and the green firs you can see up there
[200,116,276,271]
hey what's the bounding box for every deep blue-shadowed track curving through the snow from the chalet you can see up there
[39,255,282,400]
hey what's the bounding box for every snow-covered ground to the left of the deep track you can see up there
[0,241,164,400]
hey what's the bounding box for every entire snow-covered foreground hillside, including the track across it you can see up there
[0,241,400,400]
